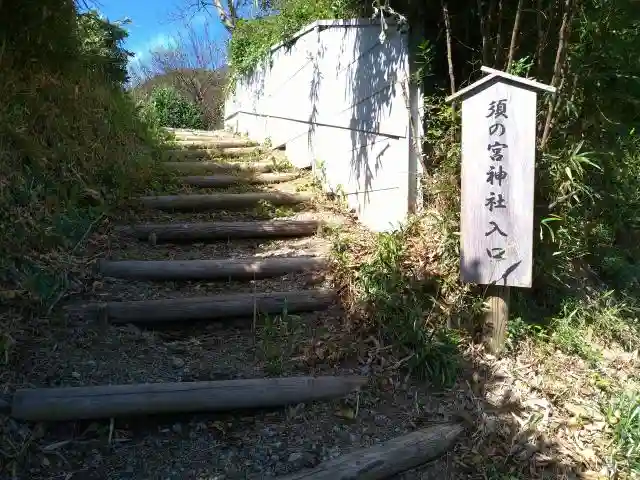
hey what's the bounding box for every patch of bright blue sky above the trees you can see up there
[94,0,228,65]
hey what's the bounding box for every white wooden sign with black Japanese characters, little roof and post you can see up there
[446,66,555,353]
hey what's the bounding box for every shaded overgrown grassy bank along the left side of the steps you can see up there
[0,0,175,312]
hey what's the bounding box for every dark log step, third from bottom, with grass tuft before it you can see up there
[85,289,335,324]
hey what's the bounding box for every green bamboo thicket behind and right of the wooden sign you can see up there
[410,0,640,359]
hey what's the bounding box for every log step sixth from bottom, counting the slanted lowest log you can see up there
[140,192,313,210]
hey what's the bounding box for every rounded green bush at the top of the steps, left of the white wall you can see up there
[141,87,205,128]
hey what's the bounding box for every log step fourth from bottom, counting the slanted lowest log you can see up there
[98,256,327,280]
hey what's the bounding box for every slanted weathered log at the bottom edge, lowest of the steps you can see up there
[282,423,464,480]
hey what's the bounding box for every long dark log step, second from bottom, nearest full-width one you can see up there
[11,376,367,421]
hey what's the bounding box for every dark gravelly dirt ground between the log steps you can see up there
[4,129,466,480]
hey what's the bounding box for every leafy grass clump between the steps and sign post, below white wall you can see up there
[333,218,474,385]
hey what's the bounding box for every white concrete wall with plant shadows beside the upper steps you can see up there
[225,16,420,231]
